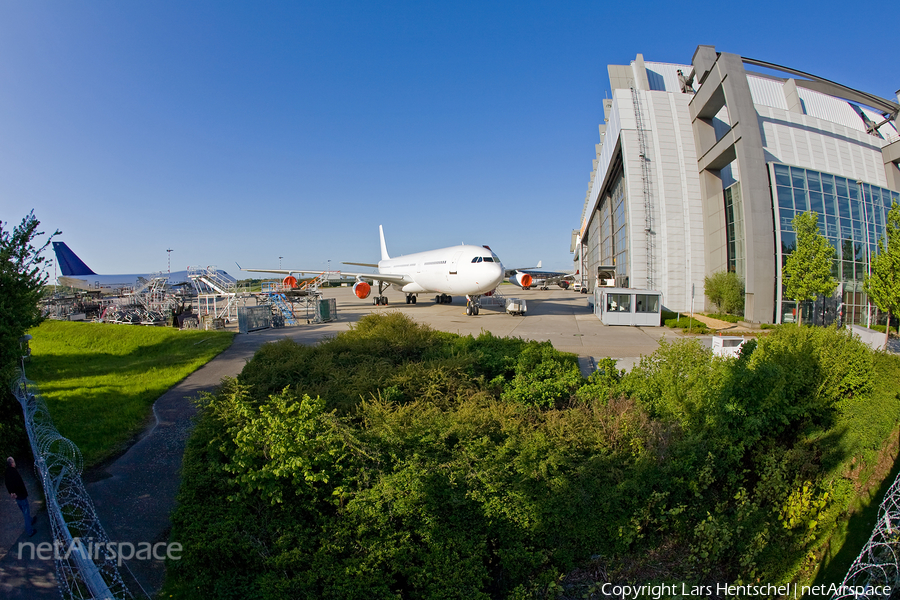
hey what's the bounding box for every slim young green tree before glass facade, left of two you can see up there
[783,211,837,326]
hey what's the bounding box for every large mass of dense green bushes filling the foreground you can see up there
[163,314,900,598]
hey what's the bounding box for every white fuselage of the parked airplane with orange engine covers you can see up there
[378,246,504,296]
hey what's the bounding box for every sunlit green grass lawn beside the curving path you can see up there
[25,321,234,466]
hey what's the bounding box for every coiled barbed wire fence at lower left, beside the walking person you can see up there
[12,369,133,600]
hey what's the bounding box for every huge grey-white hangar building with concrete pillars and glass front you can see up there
[571,46,900,323]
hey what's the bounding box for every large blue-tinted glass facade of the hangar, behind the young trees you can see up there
[768,163,900,325]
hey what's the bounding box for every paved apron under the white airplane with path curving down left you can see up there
[0,285,682,600]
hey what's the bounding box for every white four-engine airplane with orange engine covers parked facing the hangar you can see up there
[242,225,504,315]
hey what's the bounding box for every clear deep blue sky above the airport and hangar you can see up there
[0,0,900,276]
